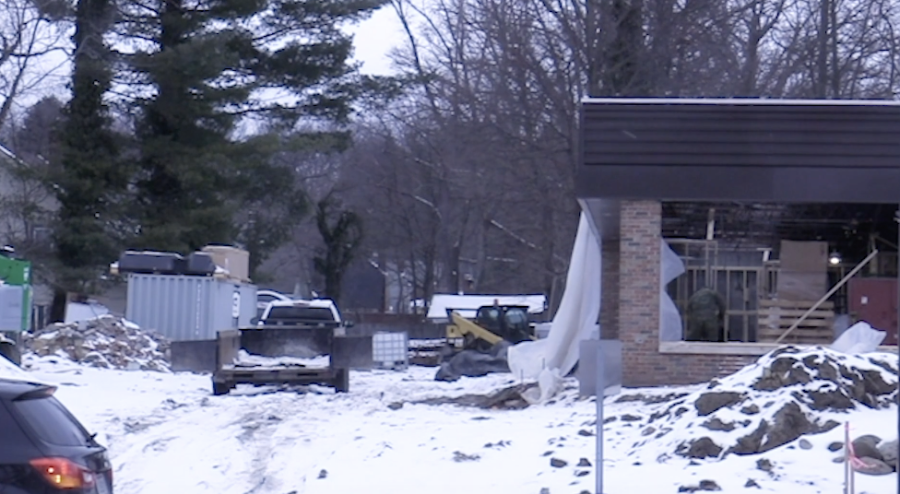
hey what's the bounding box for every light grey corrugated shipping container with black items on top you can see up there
[125,273,256,341]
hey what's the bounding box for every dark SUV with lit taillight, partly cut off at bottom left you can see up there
[0,379,113,494]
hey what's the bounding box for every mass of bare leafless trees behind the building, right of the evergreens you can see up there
[346,0,898,314]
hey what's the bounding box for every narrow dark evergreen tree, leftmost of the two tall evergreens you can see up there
[50,0,128,320]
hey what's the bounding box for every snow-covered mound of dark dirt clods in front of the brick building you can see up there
[607,347,898,458]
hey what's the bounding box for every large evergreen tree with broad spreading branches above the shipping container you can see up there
[119,0,385,255]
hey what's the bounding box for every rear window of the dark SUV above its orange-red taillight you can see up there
[13,396,88,446]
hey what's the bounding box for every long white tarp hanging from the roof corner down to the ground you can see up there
[507,212,601,402]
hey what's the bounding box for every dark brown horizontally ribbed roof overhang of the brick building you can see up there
[577,98,900,204]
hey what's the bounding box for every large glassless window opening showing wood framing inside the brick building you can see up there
[662,203,898,345]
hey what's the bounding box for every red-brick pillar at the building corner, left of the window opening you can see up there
[618,201,662,386]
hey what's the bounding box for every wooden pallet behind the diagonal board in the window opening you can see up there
[757,300,834,345]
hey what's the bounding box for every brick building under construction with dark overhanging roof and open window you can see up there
[578,99,900,385]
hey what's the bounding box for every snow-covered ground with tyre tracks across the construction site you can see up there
[12,355,897,494]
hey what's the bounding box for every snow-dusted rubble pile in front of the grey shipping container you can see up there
[24,315,169,372]
